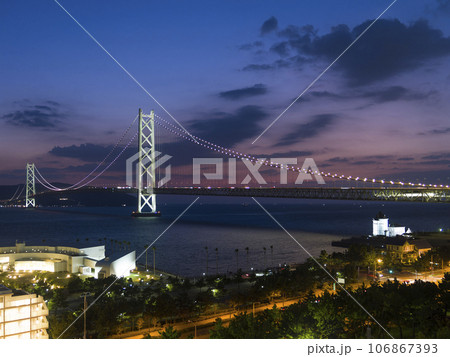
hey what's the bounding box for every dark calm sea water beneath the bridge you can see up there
[0,195,450,277]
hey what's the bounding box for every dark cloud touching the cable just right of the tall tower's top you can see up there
[189,105,268,147]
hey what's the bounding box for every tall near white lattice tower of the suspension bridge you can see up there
[132,109,161,217]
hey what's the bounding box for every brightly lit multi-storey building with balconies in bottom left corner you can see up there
[0,285,48,339]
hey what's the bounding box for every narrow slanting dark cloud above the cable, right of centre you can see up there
[276,114,338,146]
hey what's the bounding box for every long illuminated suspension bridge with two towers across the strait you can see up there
[1,109,450,209]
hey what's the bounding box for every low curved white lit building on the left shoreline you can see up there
[0,243,136,278]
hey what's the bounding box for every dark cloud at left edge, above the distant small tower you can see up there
[0,101,66,130]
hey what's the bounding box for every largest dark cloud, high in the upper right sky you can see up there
[307,19,450,86]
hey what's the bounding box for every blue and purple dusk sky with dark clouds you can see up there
[0,0,450,185]
